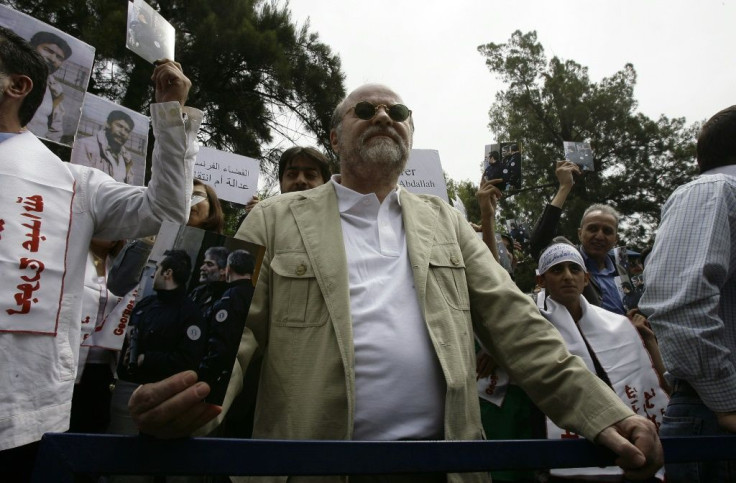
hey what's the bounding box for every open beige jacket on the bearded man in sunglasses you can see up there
[224,182,632,481]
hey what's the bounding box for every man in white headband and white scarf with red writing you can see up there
[537,238,669,479]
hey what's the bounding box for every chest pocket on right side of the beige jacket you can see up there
[428,244,470,310]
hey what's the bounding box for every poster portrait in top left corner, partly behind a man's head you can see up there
[0,5,95,146]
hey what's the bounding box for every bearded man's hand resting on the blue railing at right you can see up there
[595,415,664,480]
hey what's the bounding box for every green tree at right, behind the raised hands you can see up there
[478,31,697,253]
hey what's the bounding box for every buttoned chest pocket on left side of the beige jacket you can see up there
[271,252,328,327]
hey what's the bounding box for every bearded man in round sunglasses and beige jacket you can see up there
[130,85,662,482]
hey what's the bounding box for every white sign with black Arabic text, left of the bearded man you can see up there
[194,146,261,205]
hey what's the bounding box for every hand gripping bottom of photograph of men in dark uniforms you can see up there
[128,371,222,438]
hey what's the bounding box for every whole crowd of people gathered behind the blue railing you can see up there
[0,21,736,483]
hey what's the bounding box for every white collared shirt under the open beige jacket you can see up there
[331,175,446,440]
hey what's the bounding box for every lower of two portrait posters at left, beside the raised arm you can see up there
[71,93,149,186]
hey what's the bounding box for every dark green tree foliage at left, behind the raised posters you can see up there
[4,0,345,187]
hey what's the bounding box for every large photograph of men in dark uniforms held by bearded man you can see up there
[117,222,265,404]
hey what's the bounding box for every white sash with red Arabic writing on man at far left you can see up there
[0,134,74,335]
